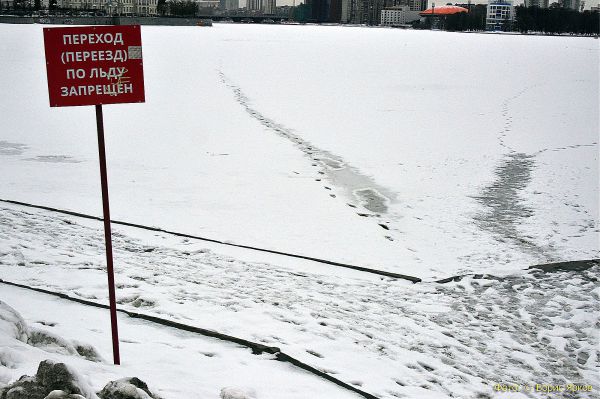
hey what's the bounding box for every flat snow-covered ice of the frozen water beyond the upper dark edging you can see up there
[0,24,599,278]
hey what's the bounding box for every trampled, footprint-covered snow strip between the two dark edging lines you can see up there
[0,207,600,398]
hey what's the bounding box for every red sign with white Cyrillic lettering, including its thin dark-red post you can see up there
[44,25,145,364]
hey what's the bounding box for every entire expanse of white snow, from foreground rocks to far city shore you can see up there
[0,24,600,399]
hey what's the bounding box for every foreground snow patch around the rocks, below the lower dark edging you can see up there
[0,286,360,399]
